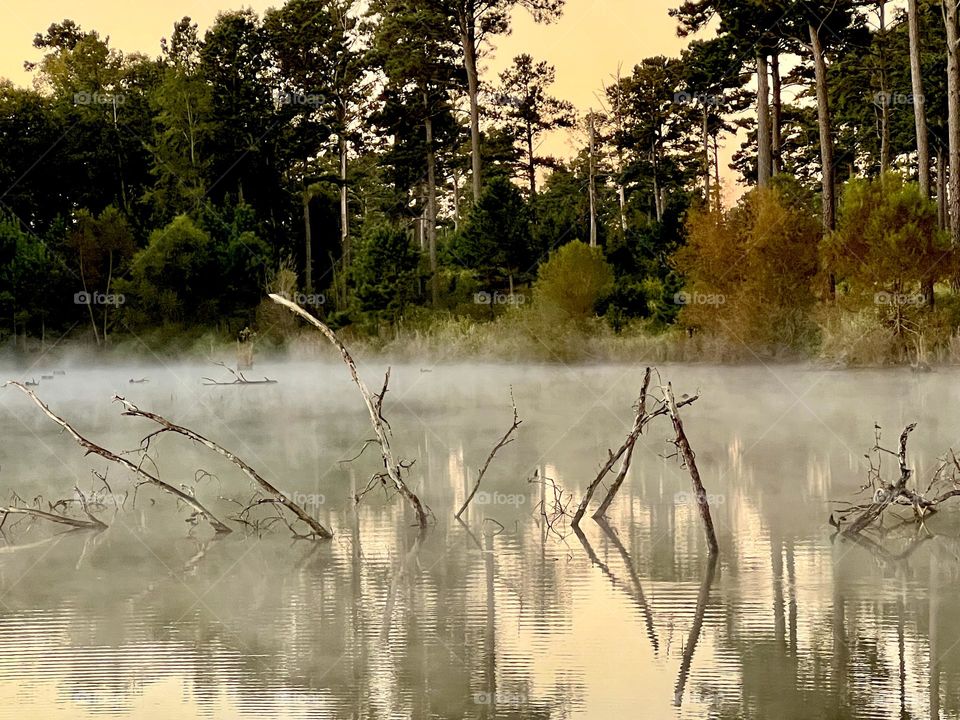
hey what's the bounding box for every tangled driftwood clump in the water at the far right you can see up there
[829,423,960,539]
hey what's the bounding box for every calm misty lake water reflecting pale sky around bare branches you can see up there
[0,362,960,719]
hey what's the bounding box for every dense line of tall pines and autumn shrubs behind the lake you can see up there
[0,0,960,360]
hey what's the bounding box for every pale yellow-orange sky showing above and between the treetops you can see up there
[0,0,735,194]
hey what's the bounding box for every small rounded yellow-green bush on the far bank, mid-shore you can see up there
[533,240,613,322]
